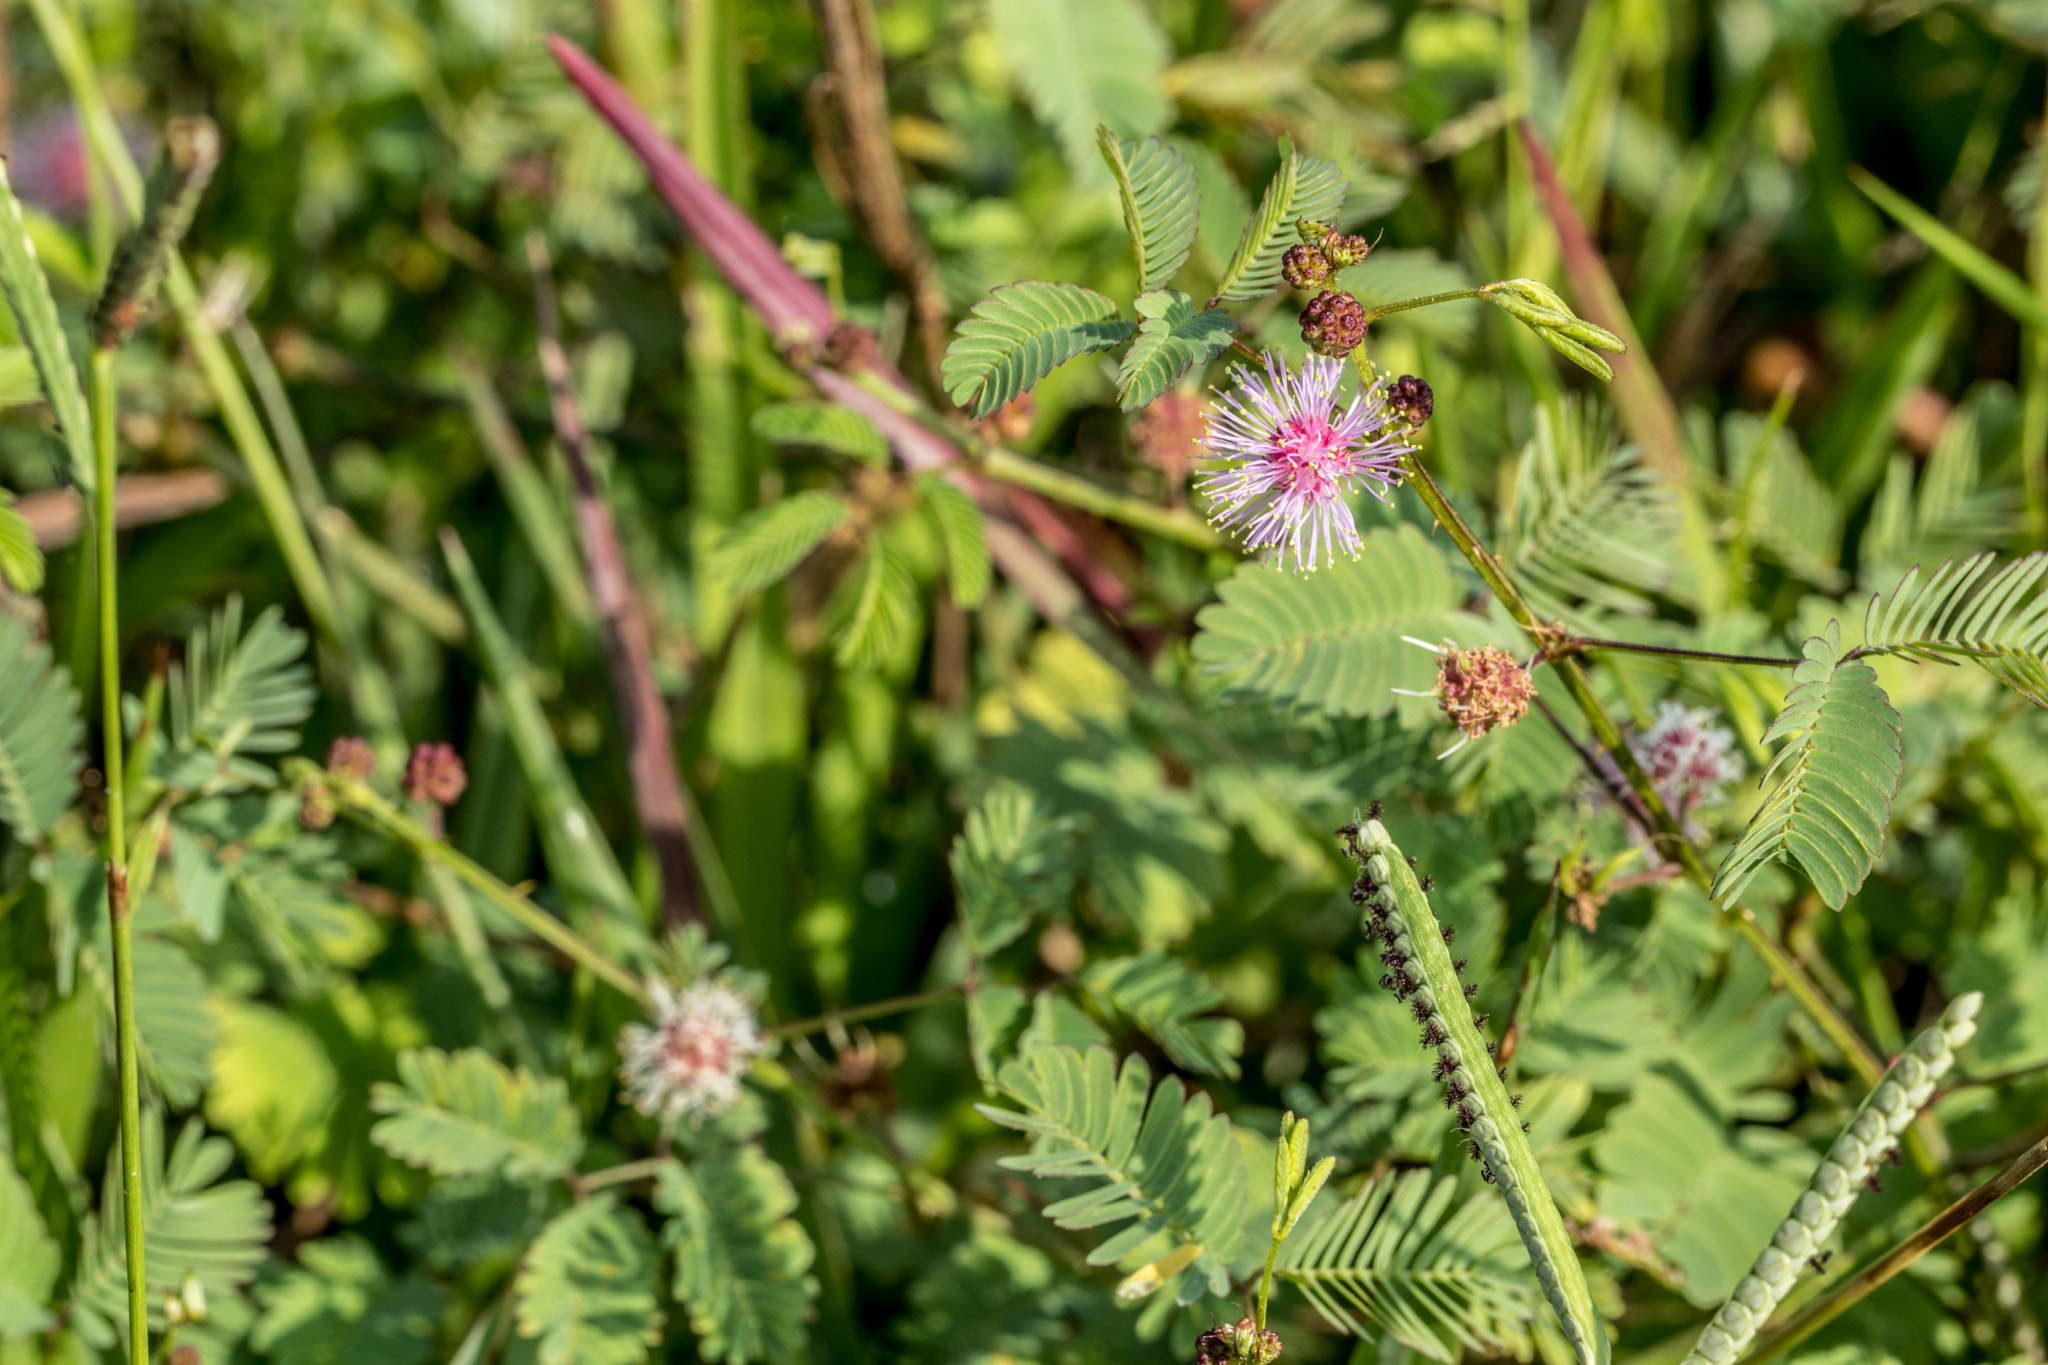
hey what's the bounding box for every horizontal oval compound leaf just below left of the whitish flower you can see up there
[371,1048,584,1179]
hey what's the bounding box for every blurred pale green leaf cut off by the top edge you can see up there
[989,0,1174,182]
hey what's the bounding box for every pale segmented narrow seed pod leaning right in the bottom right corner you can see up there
[1683,990,1985,1365]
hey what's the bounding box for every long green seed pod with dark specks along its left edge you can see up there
[1337,818,1608,1365]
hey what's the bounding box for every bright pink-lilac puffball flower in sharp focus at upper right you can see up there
[1194,352,1413,573]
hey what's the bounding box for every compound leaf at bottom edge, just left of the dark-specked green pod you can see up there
[1276,1171,1540,1365]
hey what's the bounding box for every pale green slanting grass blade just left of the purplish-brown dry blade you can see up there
[440,528,641,923]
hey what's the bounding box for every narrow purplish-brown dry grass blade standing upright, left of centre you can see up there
[526,233,705,923]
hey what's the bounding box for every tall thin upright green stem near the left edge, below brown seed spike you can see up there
[92,348,150,1365]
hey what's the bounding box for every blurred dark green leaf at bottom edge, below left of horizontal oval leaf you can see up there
[250,1236,440,1365]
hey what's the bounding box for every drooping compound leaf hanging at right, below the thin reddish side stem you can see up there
[1712,622,1905,911]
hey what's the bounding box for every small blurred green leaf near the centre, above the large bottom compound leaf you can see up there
[948,786,1073,958]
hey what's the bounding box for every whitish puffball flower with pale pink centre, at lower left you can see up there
[618,978,768,1124]
